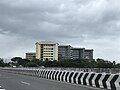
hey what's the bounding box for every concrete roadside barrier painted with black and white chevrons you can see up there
[3,68,120,90]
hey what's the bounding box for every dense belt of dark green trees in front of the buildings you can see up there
[11,57,120,68]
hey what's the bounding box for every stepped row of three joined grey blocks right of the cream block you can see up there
[58,45,93,60]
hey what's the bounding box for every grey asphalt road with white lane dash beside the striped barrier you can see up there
[0,70,103,90]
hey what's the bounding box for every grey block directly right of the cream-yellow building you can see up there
[58,45,72,60]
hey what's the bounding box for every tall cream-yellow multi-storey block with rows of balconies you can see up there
[36,41,58,61]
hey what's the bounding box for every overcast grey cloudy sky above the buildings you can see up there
[0,0,120,63]
